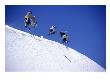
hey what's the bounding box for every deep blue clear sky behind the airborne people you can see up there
[5,5,106,68]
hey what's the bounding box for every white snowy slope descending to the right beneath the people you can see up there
[5,25,105,72]
